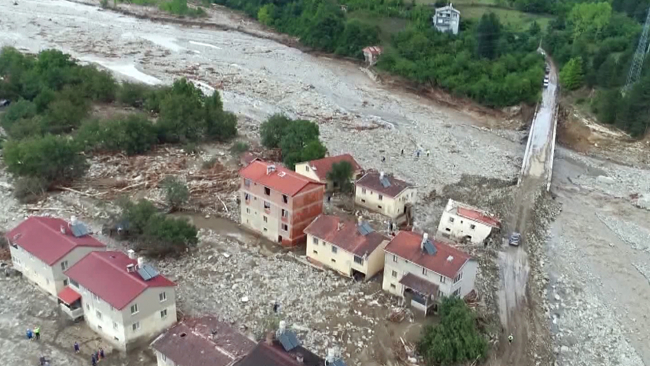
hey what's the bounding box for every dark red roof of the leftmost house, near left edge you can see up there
[5,216,106,266]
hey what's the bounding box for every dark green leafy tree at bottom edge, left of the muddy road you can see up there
[418,297,487,366]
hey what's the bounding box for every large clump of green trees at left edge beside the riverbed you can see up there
[0,47,237,190]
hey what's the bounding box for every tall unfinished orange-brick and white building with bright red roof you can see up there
[239,160,325,246]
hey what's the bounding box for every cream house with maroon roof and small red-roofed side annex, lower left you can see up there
[59,251,176,350]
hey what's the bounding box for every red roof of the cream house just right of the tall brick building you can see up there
[305,215,390,256]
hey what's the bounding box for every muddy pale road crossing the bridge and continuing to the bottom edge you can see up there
[498,55,557,366]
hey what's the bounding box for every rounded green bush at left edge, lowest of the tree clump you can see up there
[3,135,87,187]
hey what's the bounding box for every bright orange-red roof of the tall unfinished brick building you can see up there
[239,160,323,197]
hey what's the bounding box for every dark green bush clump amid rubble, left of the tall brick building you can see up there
[120,199,198,257]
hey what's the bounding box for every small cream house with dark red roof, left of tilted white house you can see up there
[354,171,417,219]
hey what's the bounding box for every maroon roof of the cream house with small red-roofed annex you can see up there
[65,251,176,310]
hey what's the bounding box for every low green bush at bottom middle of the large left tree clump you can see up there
[75,114,158,155]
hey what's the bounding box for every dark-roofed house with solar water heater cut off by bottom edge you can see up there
[235,320,345,366]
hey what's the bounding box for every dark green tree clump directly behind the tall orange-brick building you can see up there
[260,114,327,169]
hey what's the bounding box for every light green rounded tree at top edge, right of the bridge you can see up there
[568,1,612,39]
